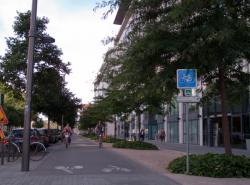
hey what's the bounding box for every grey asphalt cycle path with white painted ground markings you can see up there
[0,136,178,185]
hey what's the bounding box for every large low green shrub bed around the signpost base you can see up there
[167,153,250,177]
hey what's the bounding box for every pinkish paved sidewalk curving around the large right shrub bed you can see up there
[100,140,250,185]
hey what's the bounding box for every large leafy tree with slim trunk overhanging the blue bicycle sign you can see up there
[97,0,250,154]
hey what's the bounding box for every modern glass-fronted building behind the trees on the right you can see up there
[96,1,250,147]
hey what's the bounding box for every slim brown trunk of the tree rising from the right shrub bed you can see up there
[219,68,232,154]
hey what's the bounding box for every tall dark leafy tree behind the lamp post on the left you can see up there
[0,11,80,125]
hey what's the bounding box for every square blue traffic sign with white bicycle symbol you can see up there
[177,69,197,89]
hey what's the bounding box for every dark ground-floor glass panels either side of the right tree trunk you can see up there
[203,93,250,148]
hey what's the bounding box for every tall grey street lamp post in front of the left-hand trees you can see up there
[21,0,55,171]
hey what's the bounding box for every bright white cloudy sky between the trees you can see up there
[0,0,119,103]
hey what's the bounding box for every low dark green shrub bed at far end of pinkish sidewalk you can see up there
[113,140,158,150]
